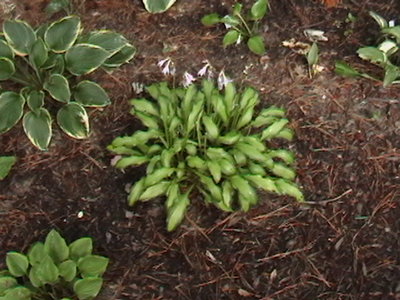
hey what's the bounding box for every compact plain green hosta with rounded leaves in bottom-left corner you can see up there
[0,230,108,300]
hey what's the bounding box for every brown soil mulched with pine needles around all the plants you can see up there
[0,0,400,300]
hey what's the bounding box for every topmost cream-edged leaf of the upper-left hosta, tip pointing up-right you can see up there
[44,16,81,53]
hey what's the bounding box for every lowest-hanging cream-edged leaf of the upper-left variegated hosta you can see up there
[23,108,52,150]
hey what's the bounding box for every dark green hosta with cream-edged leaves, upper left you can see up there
[0,16,136,150]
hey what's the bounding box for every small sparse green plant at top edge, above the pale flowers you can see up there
[201,0,270,55]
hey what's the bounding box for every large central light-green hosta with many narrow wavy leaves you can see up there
[108,80,303,231]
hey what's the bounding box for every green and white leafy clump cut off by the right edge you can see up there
[335,11,400,87]
